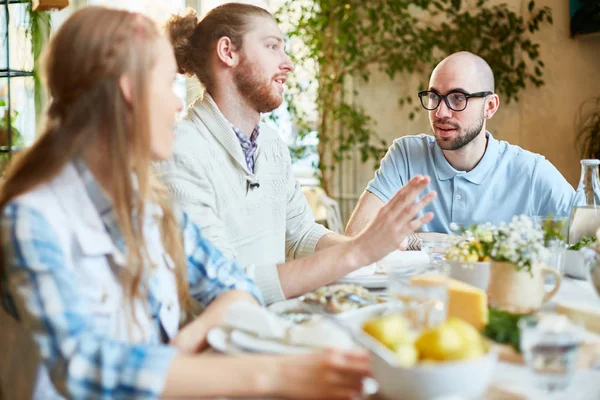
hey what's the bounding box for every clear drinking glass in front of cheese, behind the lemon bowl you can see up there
[388,264,448,328]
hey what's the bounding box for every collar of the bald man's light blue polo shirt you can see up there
[433,131,500,185]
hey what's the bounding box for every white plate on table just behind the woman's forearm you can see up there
[206,327,314,354]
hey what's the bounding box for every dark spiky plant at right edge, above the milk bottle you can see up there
[575,96,600,158]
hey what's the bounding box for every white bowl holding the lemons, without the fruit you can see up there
[371,338,498,400]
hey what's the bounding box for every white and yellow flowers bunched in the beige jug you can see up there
[446,215,547,271]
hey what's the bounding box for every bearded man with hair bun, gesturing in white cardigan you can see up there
[157,3,435,303]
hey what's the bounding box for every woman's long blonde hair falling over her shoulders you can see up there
[0,7,190,316]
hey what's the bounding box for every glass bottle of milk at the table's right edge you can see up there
[567,160,600,244]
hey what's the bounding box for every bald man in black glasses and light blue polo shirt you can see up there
[346,52,575,245]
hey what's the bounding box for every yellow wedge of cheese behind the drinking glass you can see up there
[411,275,488,330]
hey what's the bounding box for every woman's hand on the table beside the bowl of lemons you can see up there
[273,349,371,400]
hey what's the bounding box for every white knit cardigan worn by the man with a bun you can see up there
[158,93,330,303]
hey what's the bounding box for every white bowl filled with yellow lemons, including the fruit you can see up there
[359,313,497,400]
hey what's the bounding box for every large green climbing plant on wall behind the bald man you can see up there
[276,0,552,192]
